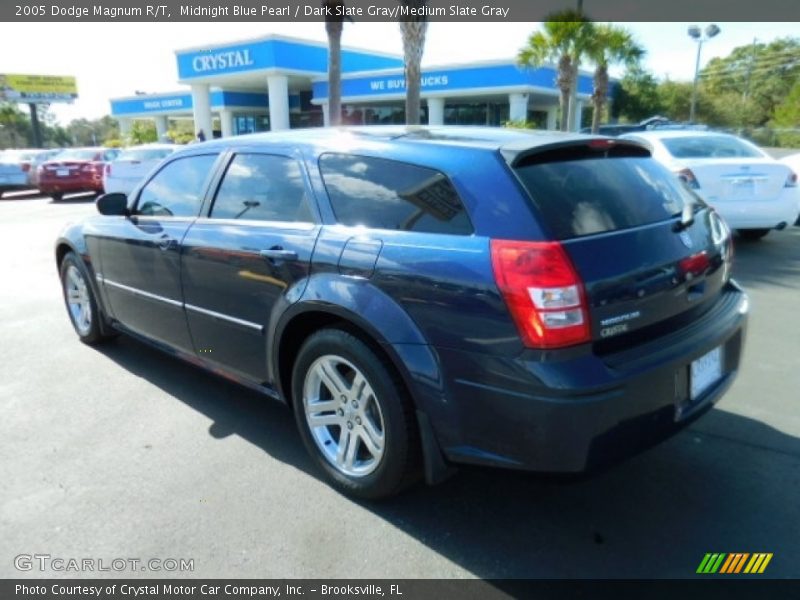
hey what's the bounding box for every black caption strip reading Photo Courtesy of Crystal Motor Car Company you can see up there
[0,576,800,600]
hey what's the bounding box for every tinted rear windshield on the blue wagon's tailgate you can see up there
[515,157,701,240]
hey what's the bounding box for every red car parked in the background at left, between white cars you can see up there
[38,148,119,202]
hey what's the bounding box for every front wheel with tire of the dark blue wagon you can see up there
[60,252,116,345]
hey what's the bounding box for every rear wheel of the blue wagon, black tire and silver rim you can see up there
[292,329,420,499]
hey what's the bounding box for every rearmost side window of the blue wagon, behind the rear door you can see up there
[319,154,473,235]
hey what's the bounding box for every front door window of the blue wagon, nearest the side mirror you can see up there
[136,154,217,217]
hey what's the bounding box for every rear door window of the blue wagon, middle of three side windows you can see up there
[211,154,313,222]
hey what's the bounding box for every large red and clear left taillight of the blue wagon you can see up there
[491,240,591,348]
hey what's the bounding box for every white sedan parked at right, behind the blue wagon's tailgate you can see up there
[620,129,800,239]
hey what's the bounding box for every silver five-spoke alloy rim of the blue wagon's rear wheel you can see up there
[303,354,386,477]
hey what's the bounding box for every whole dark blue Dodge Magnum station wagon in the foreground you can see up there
[56,127,748,498]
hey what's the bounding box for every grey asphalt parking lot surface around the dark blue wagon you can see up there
[0,190,800,578]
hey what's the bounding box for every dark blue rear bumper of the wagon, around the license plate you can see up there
[426,284,748,473]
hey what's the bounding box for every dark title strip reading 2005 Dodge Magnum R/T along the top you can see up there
[0,0,800,22]
